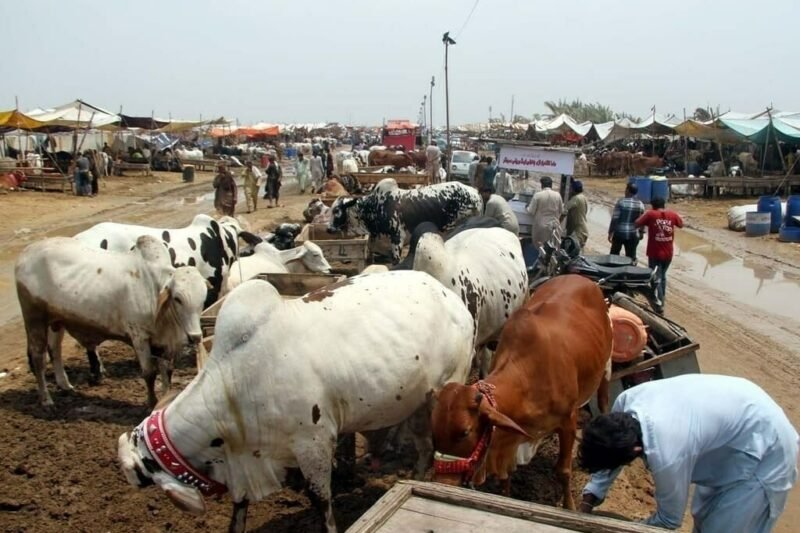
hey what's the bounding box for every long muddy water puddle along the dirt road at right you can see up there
[589,205,800,320]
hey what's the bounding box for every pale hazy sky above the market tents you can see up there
[0,0,800,125]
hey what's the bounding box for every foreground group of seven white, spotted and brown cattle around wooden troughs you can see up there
[10,178,611,531]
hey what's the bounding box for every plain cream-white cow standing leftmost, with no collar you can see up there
[14,236,207,407]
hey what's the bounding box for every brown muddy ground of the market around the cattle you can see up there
[0,168,800,532]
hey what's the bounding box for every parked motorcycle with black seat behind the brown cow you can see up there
[522,231,663,314]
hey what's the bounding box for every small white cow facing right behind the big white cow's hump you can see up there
[227,242,331,291]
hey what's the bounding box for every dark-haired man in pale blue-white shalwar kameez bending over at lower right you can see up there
[579,374,798,533]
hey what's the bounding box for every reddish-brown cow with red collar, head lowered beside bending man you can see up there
[431,275,612,509]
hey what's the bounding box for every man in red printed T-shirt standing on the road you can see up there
[635,196,683,313]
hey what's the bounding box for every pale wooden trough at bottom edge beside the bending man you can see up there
[347,481,664,533]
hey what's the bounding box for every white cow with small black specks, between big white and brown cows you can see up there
[414,228,528,375]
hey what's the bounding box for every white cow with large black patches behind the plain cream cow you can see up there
[75,215,242,307]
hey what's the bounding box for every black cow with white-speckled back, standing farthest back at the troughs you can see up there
[328,178,483,263]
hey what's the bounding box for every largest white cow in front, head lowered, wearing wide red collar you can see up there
[118,271,474,532]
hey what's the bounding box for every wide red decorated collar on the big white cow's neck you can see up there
[144,409,228,496]
